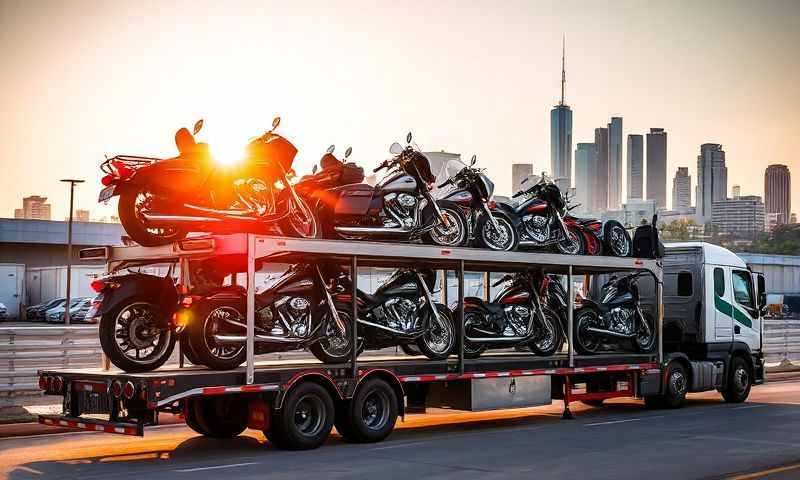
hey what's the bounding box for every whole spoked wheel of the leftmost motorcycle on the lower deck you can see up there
[99,299,175,373]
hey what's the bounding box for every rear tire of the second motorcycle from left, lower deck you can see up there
[184,299,247,370]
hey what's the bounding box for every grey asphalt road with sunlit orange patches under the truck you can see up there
[0,380,800,480]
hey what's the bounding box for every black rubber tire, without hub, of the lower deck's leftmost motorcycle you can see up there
[98,298,175,373]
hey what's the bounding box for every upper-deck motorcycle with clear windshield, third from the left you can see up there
[439,155,519,251]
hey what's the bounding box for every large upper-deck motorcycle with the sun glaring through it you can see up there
[98,118,320,247]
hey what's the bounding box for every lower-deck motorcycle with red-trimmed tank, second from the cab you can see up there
[456,271,563,358]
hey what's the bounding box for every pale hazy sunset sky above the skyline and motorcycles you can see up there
[0,0,800,219]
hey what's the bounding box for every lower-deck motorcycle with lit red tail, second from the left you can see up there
[177,264,352,370]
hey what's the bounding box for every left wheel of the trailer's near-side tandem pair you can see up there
[266,382,335,450]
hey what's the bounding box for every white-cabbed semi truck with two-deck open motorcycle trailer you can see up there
[34,234,765,449]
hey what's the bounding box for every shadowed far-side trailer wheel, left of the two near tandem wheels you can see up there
[186,395,249,438]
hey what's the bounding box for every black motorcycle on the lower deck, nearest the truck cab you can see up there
[574,272,656,354]
